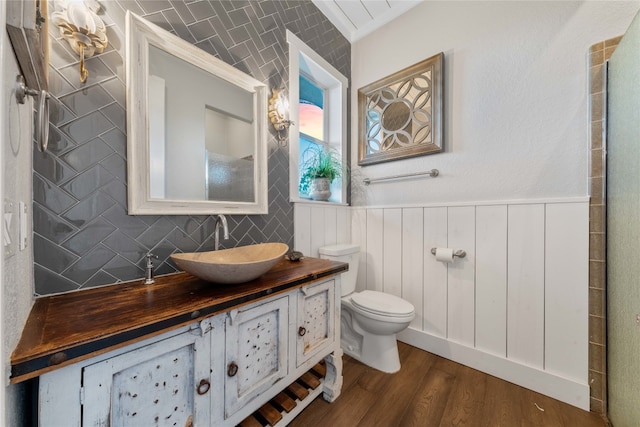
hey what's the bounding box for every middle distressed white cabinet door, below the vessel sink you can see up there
[225,296,289,418]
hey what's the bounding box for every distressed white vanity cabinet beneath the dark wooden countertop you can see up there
[14,260,344,427]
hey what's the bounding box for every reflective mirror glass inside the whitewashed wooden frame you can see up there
[149,46,255,202]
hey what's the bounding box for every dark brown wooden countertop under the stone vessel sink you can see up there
[11,257,348,383]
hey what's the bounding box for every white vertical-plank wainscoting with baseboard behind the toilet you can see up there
[294,197,589,410]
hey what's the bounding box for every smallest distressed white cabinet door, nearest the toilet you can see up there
[296,280,336,366]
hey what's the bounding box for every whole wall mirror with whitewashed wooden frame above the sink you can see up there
[126,12,268,215]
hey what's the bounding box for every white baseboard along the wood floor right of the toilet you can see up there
[398,328,589,411]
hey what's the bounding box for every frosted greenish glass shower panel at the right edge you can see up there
[606,10,640,427]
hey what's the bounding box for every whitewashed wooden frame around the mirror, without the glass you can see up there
[126,11,269,215]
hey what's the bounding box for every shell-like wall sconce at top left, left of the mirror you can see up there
[51,0,108,83]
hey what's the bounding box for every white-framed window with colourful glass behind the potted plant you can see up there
[287,31,348,203]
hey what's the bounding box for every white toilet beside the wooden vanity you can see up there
[318,244,415,373]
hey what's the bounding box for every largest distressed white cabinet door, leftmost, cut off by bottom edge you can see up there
[82,330,211,427]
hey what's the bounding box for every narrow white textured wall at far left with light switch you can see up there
[0,2,35,426]
